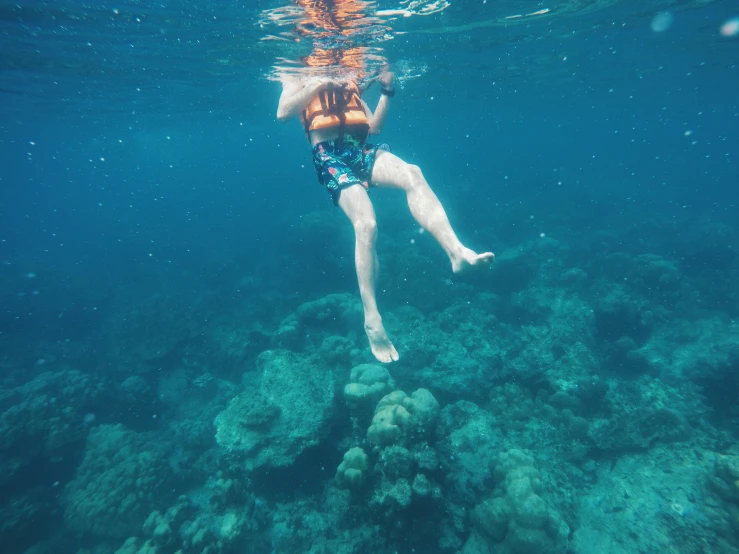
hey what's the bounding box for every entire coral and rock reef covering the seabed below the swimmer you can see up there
[0,206,739,554]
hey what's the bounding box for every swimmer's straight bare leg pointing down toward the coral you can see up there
[339,185,398,363]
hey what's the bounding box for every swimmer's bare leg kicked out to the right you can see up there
[372,150,495,273]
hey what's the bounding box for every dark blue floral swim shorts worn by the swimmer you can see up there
[313,135,390,205]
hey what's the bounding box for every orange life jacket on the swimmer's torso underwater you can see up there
[300,83,369,139]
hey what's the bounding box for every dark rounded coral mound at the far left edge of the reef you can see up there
[0,365,108,544]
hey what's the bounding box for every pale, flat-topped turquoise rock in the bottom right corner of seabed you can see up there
[569,441,724,554]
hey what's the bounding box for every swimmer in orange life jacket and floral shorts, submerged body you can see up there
[277,12,494,362]
